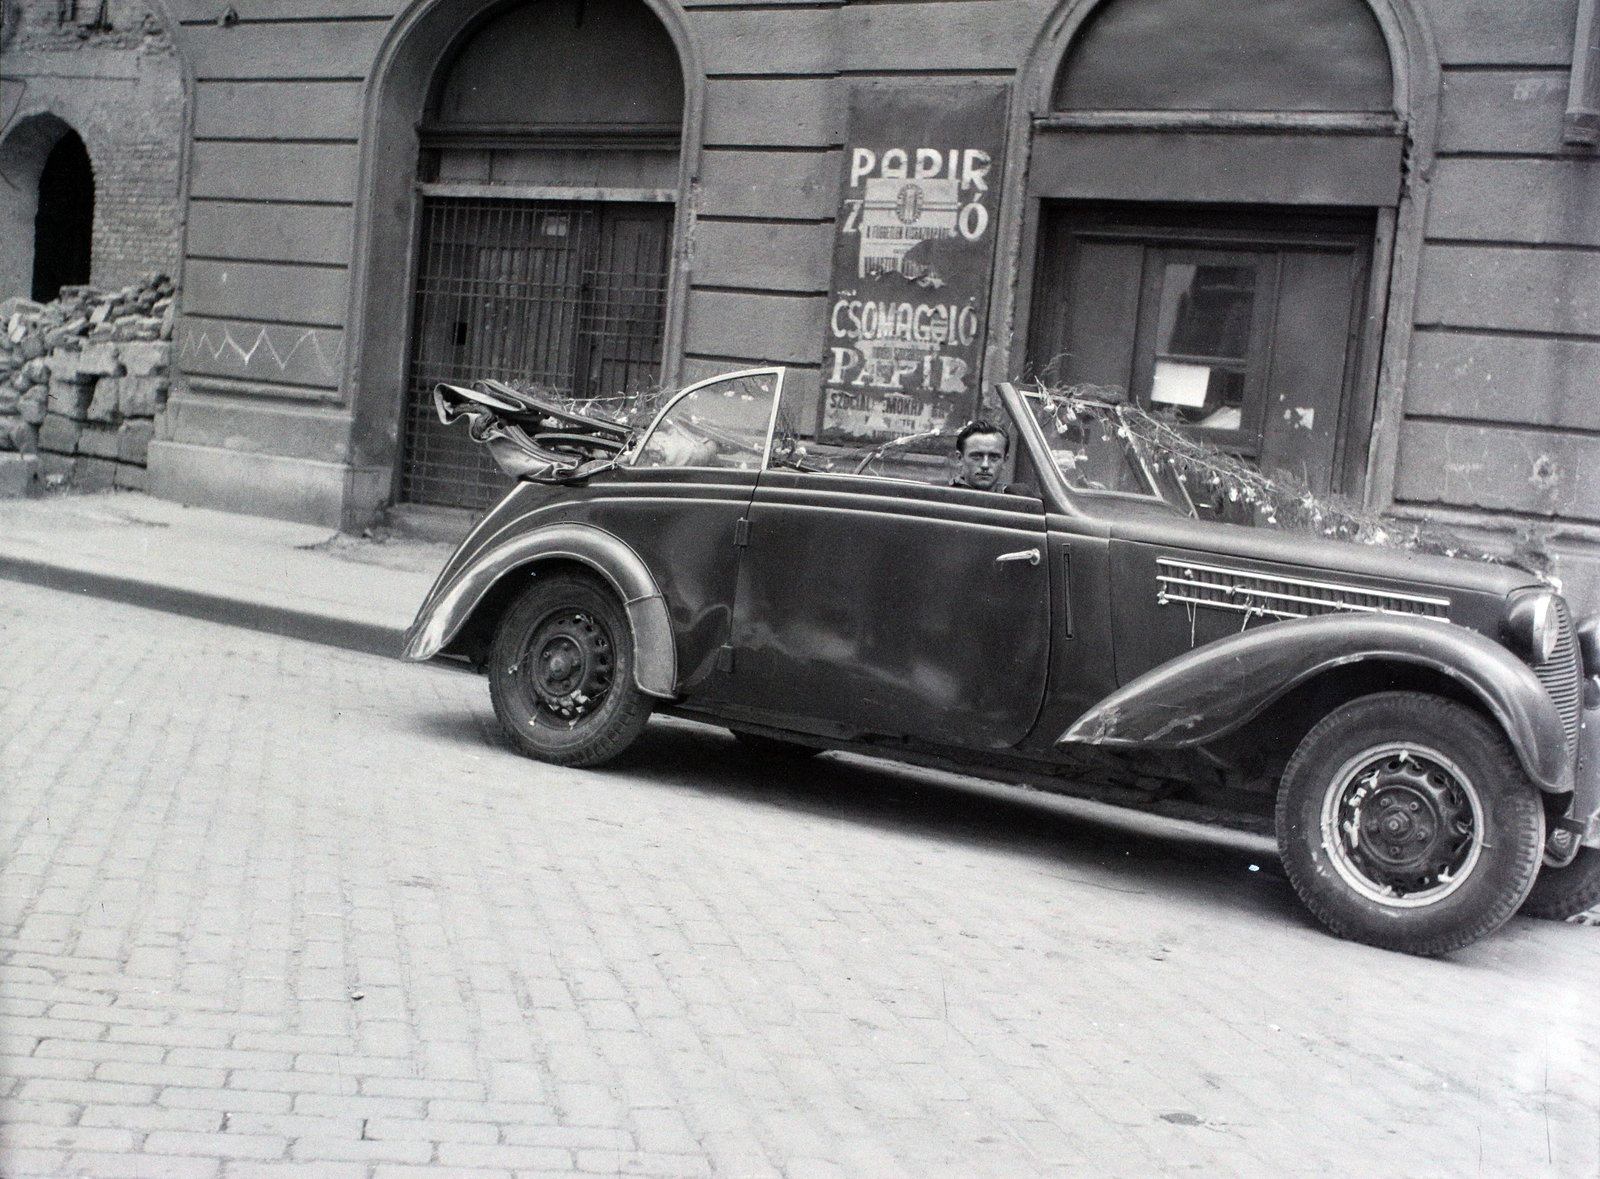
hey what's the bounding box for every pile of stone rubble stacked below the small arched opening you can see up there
[0,274,174,498]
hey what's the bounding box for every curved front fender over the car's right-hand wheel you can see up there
[1058,614,1571,790]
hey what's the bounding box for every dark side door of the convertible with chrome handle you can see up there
[725,395,1050,749]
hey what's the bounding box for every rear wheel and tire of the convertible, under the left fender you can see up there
[488,573,651,766]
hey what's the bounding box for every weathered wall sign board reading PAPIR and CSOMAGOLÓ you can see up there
[821,85,1010,442]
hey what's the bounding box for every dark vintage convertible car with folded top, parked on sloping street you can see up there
[406,368,1600,953]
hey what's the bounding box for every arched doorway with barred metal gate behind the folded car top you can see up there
[398,0,683,509]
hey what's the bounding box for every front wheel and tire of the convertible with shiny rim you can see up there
[1277,693,1544,955]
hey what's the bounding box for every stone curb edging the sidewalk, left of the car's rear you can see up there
[0,554,405,659]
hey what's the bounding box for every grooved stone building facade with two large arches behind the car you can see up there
[9,0,1600,606]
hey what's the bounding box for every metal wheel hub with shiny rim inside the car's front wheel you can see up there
[1330,747,1480,899]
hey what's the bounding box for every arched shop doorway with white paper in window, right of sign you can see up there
[1019,0,1405,496]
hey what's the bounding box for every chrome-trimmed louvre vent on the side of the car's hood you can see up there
[1155,558,1450,619]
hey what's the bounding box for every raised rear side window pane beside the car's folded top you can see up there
[634,373,776,470]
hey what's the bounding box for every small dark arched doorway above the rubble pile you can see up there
[0,114,94,302]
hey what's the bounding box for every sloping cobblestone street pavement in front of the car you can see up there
[9,582,1600,1179]
